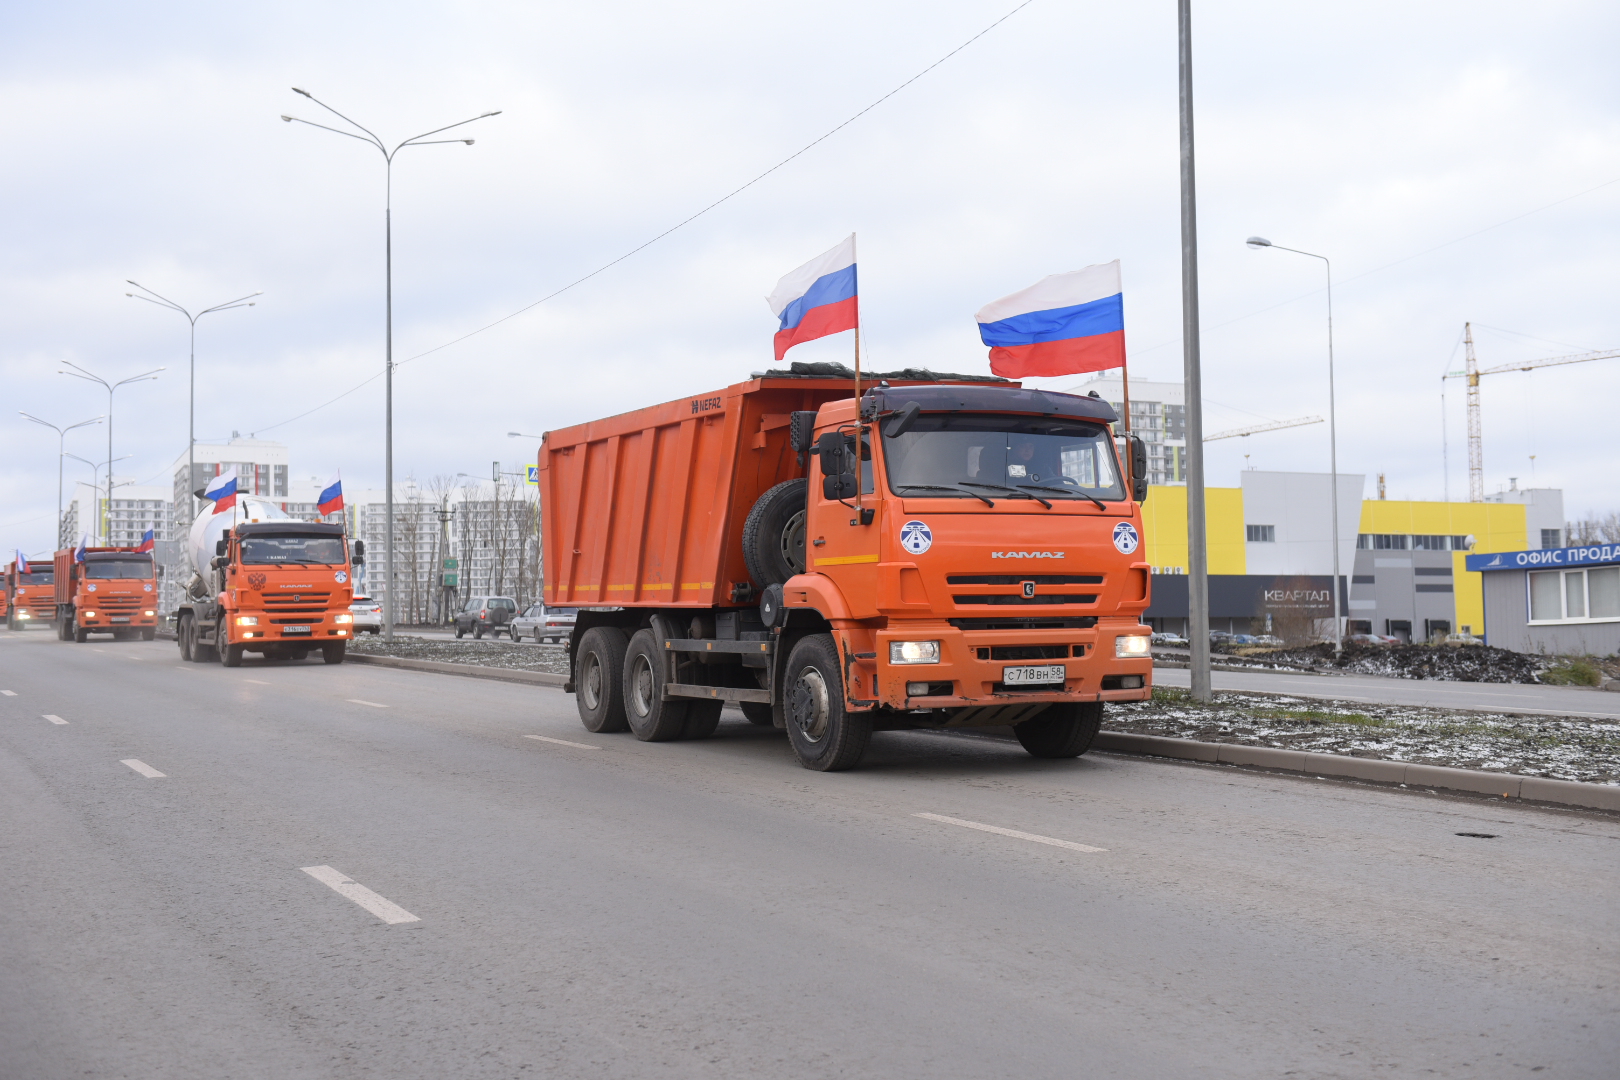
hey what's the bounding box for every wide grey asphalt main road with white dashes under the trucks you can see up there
[9,631,1620,1080]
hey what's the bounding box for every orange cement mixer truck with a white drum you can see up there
[175,495,365,667]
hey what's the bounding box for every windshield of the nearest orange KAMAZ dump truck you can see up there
[881,413,1124,500]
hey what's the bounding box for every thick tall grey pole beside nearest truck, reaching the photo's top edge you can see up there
[1176,0,1212,704]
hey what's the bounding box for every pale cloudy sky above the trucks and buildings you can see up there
[0,0,1620,552]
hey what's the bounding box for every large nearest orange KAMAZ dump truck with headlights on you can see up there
[539,364,1152,771]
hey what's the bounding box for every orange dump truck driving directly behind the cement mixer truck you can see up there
[53,547,157,644]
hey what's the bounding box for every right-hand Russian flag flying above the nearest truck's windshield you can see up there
[974,259,1124,379]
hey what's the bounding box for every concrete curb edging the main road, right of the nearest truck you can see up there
[1092,732,1620,811]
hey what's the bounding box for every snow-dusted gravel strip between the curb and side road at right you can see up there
[1103,687,1620,784]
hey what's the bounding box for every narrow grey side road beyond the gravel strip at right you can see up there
[1153,667,1620,719]
